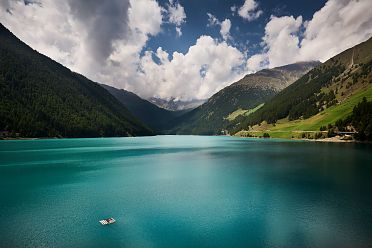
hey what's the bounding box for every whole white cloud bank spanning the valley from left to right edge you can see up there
[0,0,372,100]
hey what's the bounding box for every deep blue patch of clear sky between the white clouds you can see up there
[145,0,326,54]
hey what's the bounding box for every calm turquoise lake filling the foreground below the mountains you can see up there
[0,136,372,248]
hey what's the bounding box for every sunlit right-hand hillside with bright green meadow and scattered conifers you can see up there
[230,36,372,138]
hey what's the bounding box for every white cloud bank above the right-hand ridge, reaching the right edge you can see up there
[247,0,372,70]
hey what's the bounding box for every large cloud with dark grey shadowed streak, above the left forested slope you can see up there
[0,0,163,75]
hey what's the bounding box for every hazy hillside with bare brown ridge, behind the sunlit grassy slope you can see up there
[173,61,319,135]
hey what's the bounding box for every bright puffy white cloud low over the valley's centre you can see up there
[137,36,245,100]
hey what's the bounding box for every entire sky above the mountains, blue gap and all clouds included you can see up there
[0,0,372,100]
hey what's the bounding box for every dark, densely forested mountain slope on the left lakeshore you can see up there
[0,24,152,137]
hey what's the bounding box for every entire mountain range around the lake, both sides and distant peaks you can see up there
[0,21,372,138]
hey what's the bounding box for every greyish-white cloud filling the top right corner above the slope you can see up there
[300,0,372,61]
